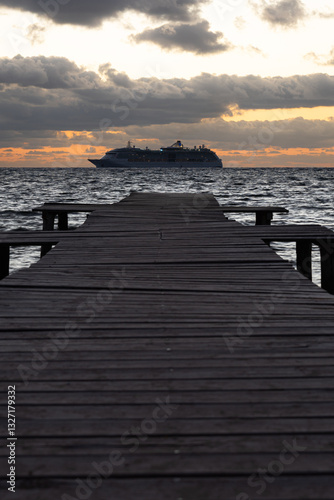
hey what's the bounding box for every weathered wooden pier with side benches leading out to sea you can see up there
[0,193,334,500]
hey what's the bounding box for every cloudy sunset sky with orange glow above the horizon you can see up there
[0,0,334,167]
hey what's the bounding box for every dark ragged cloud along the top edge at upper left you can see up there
[0,0,208,27]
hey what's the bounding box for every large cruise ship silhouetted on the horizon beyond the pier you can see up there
[88,141,223,168]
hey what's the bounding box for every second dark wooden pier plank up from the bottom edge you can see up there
[0,452,334,479]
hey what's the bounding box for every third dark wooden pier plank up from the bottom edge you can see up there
[0,433,333,460]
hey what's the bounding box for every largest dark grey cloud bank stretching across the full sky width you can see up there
[0,56,334,135]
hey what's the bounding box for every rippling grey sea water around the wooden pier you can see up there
[0,168,334,284]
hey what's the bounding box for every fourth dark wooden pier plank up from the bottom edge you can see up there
[0,416,334,436]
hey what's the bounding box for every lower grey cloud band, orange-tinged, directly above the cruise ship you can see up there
[0,118,334,155]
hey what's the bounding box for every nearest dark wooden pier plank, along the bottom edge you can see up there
[4,476,334,500]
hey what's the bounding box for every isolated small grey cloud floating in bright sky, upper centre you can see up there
[131,20,231,54]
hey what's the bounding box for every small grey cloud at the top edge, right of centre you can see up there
[260,0,306,28]
